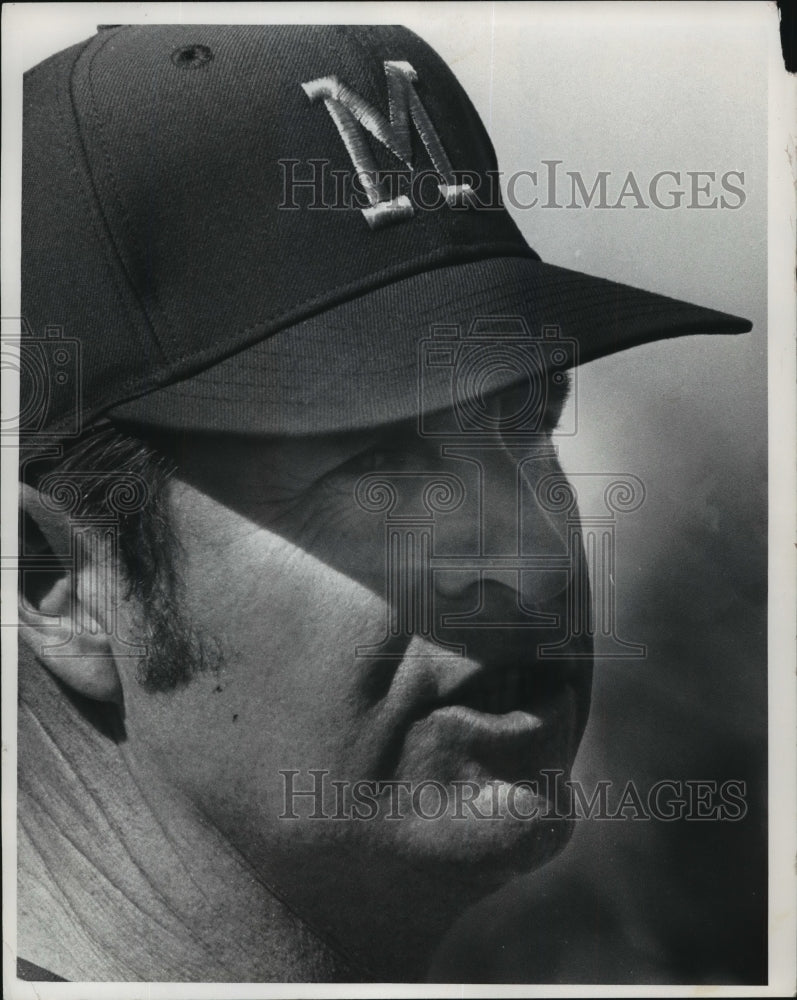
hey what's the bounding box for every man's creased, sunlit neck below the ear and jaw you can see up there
[18,657,363,982]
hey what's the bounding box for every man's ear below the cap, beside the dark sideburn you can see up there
[19,483,122,704]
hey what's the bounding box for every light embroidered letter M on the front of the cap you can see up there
[302,62,472,229]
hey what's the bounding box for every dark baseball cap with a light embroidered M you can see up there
[22,25,751,436]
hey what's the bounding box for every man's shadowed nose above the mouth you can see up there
[434,444,573,612]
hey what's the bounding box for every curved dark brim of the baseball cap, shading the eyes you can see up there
[110,257,752,434]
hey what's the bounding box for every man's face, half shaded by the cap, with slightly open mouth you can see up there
[118,380,591,908]
